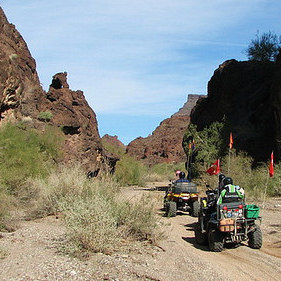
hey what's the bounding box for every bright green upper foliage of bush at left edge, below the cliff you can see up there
[0,124,60,195]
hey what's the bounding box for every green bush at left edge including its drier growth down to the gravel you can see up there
[0,123,62,229]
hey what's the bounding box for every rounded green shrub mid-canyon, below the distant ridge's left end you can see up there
[114,155,147,185]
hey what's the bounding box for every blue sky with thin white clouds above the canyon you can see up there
[0,0,281,144]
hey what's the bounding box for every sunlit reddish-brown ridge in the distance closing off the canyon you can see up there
[127,95,203,164]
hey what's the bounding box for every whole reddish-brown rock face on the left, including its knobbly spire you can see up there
[0,8,117,175]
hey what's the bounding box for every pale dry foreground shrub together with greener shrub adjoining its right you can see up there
[60,188,158,254]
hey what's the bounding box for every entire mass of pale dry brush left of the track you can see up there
[24,166,158,254]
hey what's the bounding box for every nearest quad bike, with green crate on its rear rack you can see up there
[195,185,262,252]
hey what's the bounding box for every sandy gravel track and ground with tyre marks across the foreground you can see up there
[0,185,281,281]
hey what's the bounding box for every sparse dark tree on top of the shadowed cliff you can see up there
[246,31,281,62]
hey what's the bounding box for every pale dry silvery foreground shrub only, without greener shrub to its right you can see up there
[60,192,120,253]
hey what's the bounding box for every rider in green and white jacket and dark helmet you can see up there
[217,177,244,205]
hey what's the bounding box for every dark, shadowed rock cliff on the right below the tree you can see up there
[191,60,281,161]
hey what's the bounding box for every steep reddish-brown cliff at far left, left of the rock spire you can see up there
[0,8,42,120]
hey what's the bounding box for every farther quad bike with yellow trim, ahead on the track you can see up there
[164,182,200,217]
